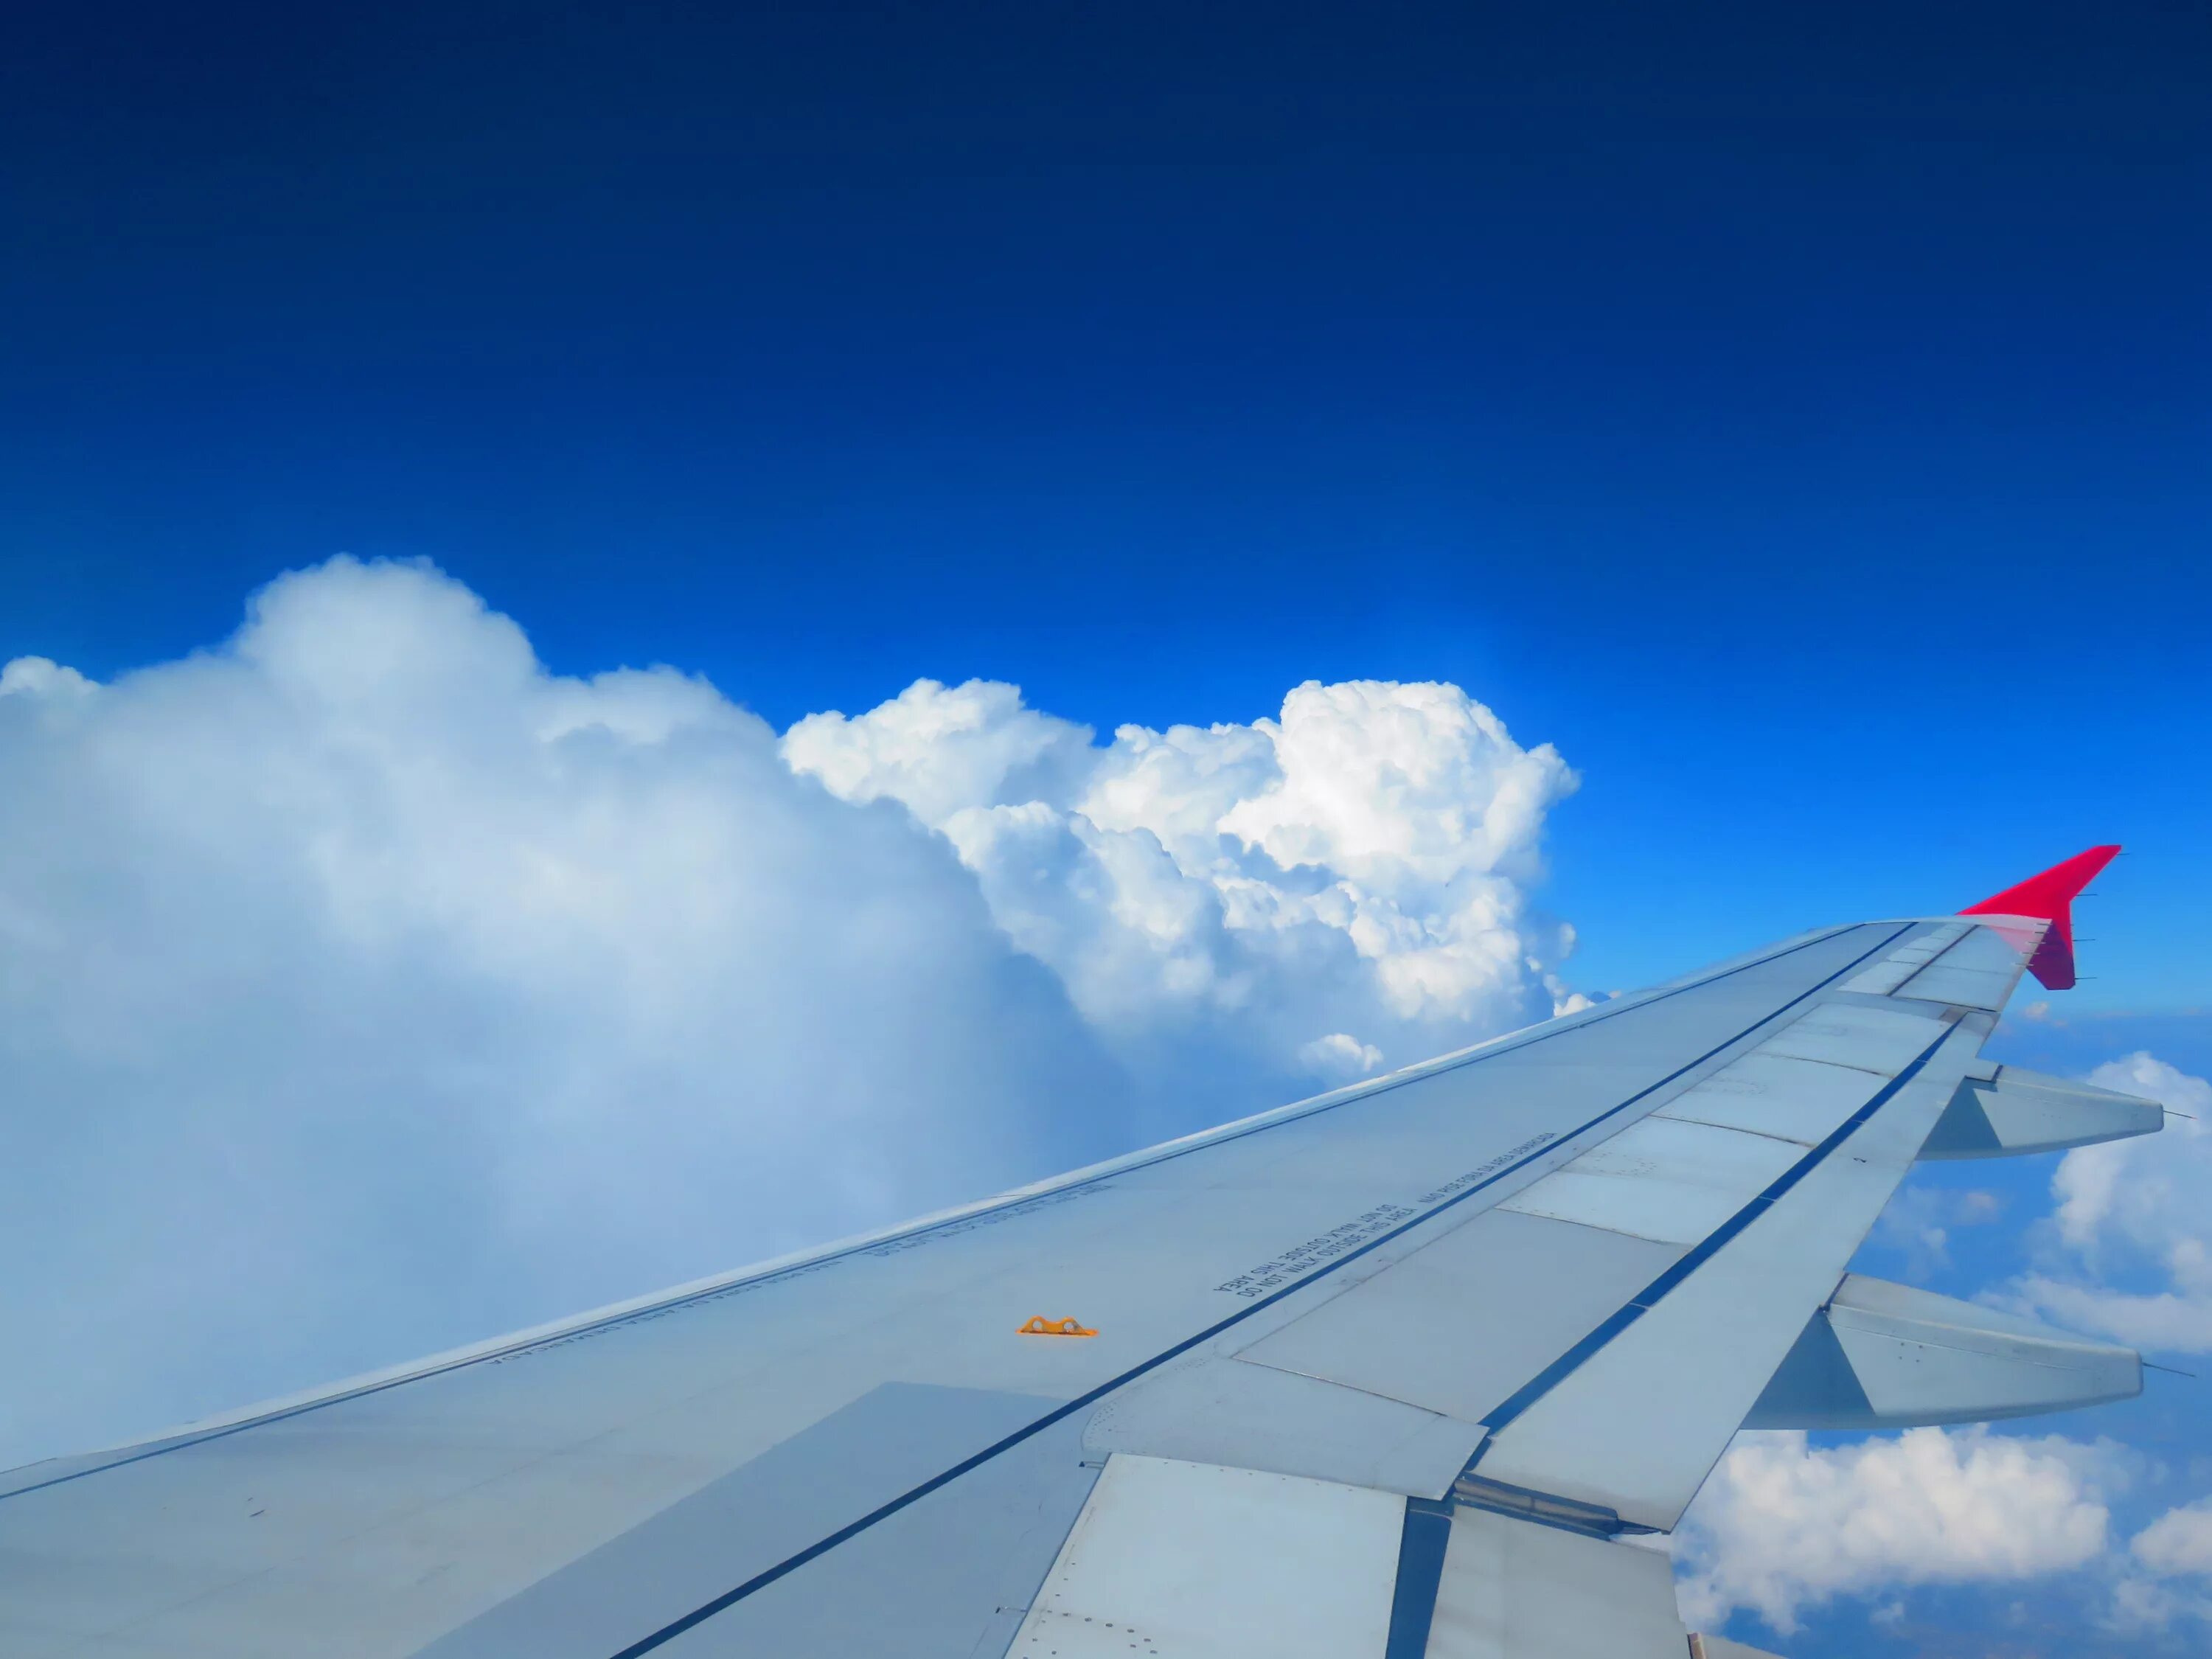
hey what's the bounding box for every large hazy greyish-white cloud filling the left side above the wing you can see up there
[0,560,1130,1462]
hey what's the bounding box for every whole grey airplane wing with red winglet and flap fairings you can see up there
[0,847,2161,1659]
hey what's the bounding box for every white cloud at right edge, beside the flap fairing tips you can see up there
[2004,1053,2212,1354]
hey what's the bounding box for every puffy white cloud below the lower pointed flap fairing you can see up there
[1677,1429,2126,1632]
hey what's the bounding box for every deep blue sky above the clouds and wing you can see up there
[0,0,2212,1009]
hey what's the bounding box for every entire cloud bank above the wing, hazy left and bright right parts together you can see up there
[0,560,1573,1464]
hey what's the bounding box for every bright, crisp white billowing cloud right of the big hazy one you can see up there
[783,681,1575,1075]
